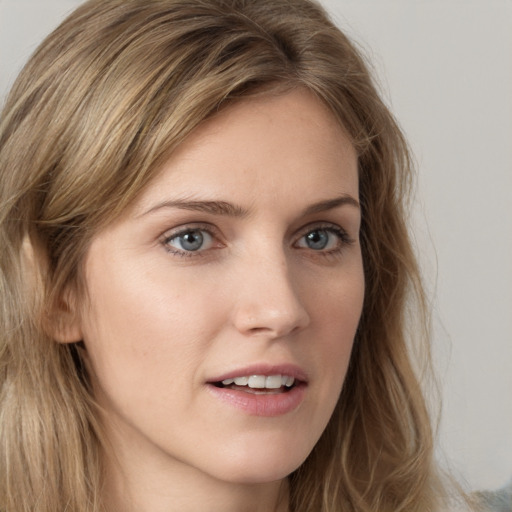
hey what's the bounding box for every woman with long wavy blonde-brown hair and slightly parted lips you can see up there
[0,0,456,512]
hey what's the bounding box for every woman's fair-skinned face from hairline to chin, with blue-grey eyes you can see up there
[78,90,364,483]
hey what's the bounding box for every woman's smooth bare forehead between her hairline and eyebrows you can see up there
[133,89,358,214]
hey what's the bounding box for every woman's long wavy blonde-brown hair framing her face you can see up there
[0,0,442,512]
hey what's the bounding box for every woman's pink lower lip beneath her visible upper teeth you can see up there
[207,383,306,417]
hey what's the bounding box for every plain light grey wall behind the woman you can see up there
[0,0,512,489]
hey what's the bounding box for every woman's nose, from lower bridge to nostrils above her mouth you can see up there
[234,253,310,339]
